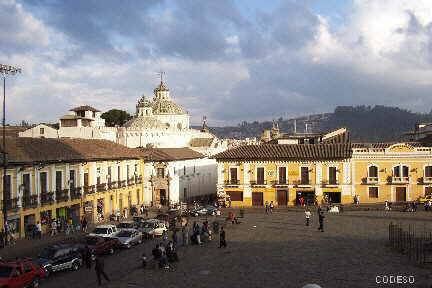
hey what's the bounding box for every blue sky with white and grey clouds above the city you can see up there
[0,0,432,126]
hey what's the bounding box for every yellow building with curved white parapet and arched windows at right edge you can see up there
[352,142,432,203]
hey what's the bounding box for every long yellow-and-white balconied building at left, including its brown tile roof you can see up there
[0,138,144,237]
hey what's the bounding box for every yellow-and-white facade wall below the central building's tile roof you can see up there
[218,160,352,207]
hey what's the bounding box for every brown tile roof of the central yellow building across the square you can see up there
[214,143,352,160]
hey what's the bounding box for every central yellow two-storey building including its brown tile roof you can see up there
[215,143,353,206]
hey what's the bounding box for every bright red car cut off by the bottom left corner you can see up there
[0,259,45,288]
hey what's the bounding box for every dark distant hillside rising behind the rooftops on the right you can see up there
[210,106,432,142]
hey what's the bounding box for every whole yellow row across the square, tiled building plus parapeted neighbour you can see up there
[215,142,432,206]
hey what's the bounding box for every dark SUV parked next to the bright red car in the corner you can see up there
[37,244,82,277]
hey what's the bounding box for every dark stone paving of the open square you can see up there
[3,210,432,288]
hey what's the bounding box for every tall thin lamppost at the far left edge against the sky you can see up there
[0,64,21,246]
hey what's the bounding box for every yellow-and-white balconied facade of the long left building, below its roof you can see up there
[0,159,144,237]
